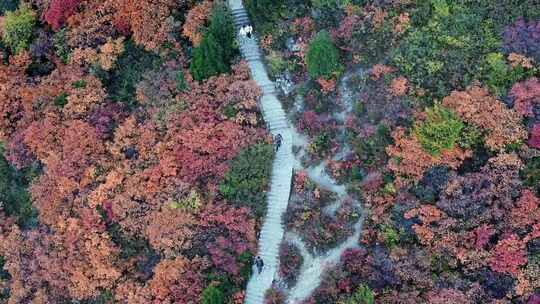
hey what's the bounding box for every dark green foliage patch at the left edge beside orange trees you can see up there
[0,144,37,229]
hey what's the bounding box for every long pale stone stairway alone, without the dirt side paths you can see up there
[228,0,294,304]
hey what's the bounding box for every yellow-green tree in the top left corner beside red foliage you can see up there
[2,5,37,54]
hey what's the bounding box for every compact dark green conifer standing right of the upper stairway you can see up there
[306,30,342,78]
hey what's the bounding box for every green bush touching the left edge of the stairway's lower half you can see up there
[219,143,273,215]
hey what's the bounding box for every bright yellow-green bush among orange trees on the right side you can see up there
[414,105,465,156]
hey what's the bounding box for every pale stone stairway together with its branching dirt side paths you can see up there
[228,0,363,304]
